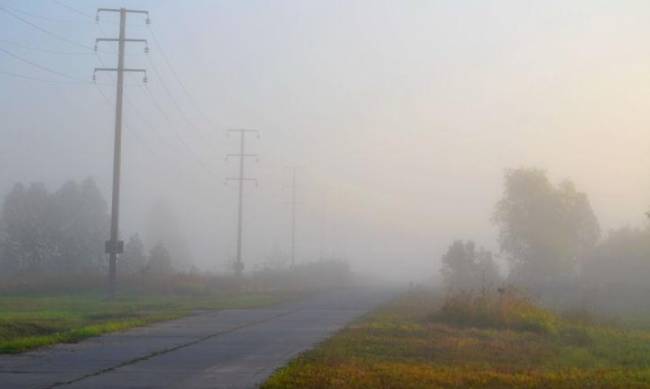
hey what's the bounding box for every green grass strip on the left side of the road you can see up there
[0,275,300,353]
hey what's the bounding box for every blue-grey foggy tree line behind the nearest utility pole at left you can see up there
[0,178,173,276]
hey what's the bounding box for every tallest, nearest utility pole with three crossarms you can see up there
[93,8,149,298]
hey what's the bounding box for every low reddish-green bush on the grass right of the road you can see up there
[432,289,559,333]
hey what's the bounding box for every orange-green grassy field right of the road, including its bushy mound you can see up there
[263,290,650,389]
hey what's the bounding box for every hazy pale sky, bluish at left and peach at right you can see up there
[0,0,650,278]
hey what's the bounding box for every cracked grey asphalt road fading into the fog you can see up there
[0,288,392,389]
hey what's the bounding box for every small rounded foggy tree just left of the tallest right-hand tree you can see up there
[440,240,500,289]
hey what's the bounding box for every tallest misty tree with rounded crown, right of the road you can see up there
[493,169,600,286]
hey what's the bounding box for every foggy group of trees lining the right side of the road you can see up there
[441,168,650,308]
